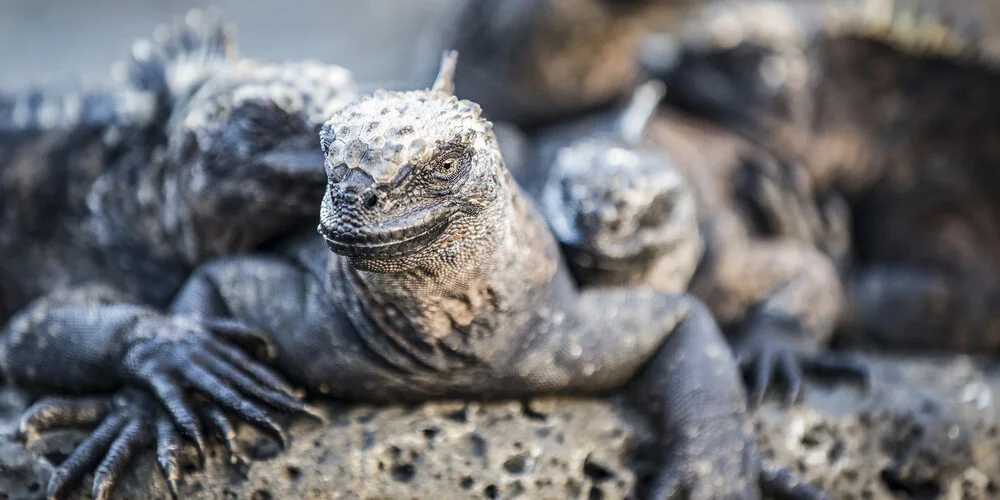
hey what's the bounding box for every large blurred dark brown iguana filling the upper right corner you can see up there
[652,1,1000,353]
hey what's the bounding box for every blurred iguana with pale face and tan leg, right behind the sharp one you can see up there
[504,82,866,403]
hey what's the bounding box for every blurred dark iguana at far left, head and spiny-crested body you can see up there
[0,11,355,324]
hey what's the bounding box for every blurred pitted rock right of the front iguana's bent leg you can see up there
[757,356,1000,499]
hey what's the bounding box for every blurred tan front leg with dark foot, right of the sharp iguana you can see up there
[692,234,868,405]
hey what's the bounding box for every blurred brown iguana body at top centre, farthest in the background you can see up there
[451,0,699,127]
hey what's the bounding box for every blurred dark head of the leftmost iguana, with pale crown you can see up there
[165,60,356,251]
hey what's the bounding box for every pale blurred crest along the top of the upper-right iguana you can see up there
[683,0,1000,67]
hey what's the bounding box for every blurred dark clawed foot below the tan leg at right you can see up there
[734,332,871,408]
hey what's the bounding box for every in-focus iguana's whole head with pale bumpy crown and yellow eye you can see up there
[319,51,509,272]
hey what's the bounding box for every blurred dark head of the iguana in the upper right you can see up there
[642,0,824,147]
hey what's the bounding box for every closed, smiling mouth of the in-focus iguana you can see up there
[320,210,451,259]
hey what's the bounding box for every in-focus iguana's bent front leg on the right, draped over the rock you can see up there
[514,289,823,499]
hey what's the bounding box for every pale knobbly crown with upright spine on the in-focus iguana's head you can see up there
[320,50,496,182]
